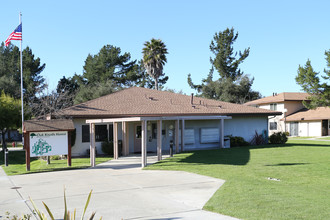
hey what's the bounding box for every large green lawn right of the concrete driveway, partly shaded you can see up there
[146,140,330,219]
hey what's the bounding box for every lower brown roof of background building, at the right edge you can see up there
[282,107,330,121]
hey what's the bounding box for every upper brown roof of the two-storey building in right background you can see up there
[244,92,309,106]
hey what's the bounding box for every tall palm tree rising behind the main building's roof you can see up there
[142,38,168,90]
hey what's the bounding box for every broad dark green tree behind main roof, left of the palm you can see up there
[66,45,149,104]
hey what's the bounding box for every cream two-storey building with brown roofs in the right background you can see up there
[244,92,330,136]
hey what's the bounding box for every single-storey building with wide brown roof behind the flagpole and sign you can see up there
[63,87,281,162]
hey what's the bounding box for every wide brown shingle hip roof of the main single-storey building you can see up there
[63,87,281,118]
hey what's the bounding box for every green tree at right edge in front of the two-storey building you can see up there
[296,50,330,109]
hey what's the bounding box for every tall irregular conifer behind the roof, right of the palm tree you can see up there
[188,28,261,104]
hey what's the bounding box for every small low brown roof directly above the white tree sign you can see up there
[24,119,74,132]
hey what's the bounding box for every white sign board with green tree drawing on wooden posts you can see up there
[29,131,68,157]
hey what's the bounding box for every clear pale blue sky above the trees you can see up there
[0,0,330,96]
